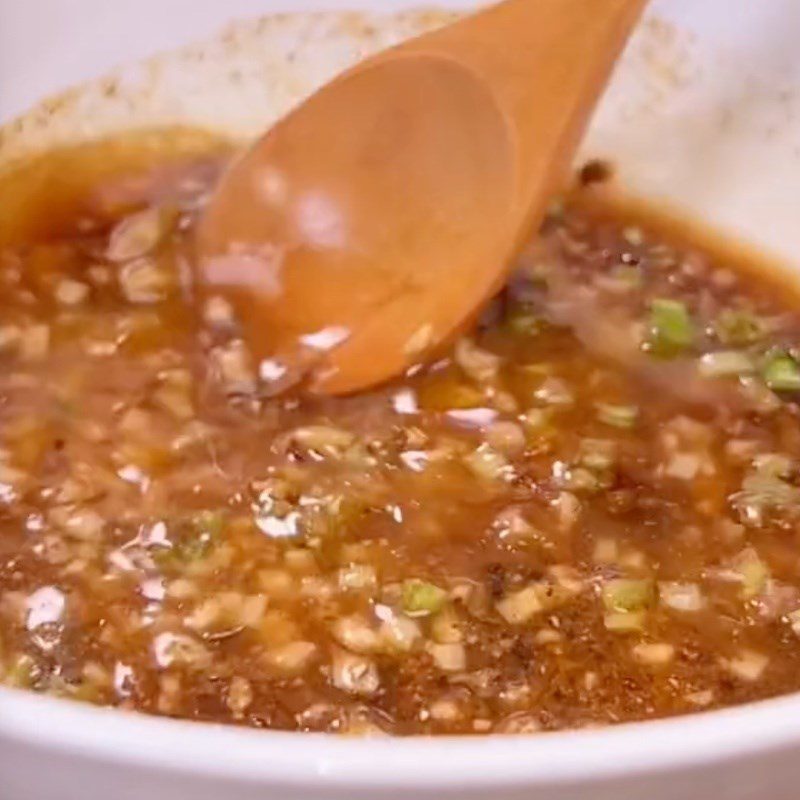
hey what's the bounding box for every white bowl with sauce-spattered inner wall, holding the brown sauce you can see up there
[0,0,800,800]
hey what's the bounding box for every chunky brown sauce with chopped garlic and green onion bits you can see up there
[0,131,800,734]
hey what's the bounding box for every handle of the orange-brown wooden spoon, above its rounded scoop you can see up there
[382,0,647,227]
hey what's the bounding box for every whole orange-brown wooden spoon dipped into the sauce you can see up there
[197,0,645,394]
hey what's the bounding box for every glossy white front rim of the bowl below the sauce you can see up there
[0,688,800,790]
